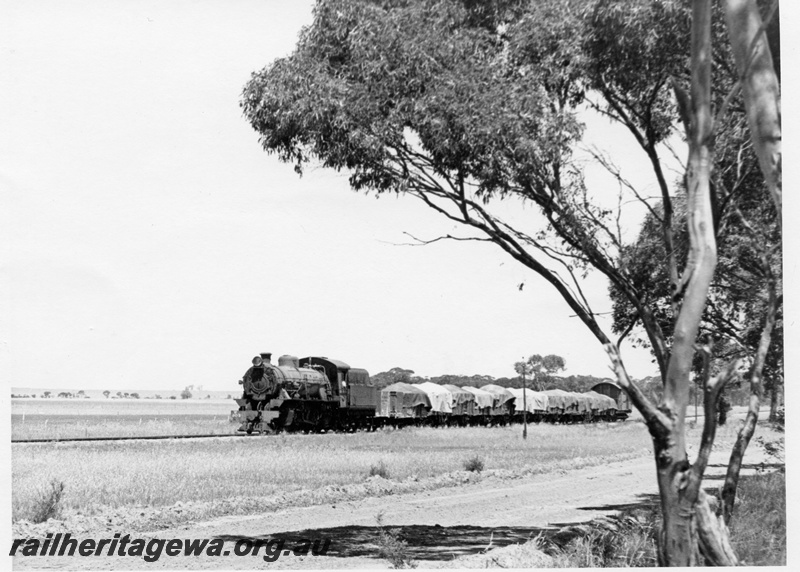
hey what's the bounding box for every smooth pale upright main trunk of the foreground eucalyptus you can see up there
[648,0,717,566]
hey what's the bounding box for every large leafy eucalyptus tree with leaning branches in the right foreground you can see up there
[241,0,780,565]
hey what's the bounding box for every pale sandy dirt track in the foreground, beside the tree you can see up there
[13,418,772,569]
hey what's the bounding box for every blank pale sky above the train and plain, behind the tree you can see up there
[0,0,791,390]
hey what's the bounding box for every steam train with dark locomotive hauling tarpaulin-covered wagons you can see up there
[232,353,630,434]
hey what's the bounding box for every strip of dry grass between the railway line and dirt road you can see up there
[12,423,650,521]
